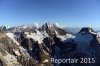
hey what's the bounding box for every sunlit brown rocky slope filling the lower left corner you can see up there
[0,30,36,66]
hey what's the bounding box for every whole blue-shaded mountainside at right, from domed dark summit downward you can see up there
[74,27,100,66]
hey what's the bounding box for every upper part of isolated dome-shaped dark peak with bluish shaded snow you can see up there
[75,27,97,44]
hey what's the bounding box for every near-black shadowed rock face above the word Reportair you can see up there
[52,36,77,66]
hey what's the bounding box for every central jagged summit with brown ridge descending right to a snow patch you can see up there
[39,23,75,41]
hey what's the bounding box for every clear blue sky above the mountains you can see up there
[0,0,100,27]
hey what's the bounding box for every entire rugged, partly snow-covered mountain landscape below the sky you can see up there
[0,23,100,66]
